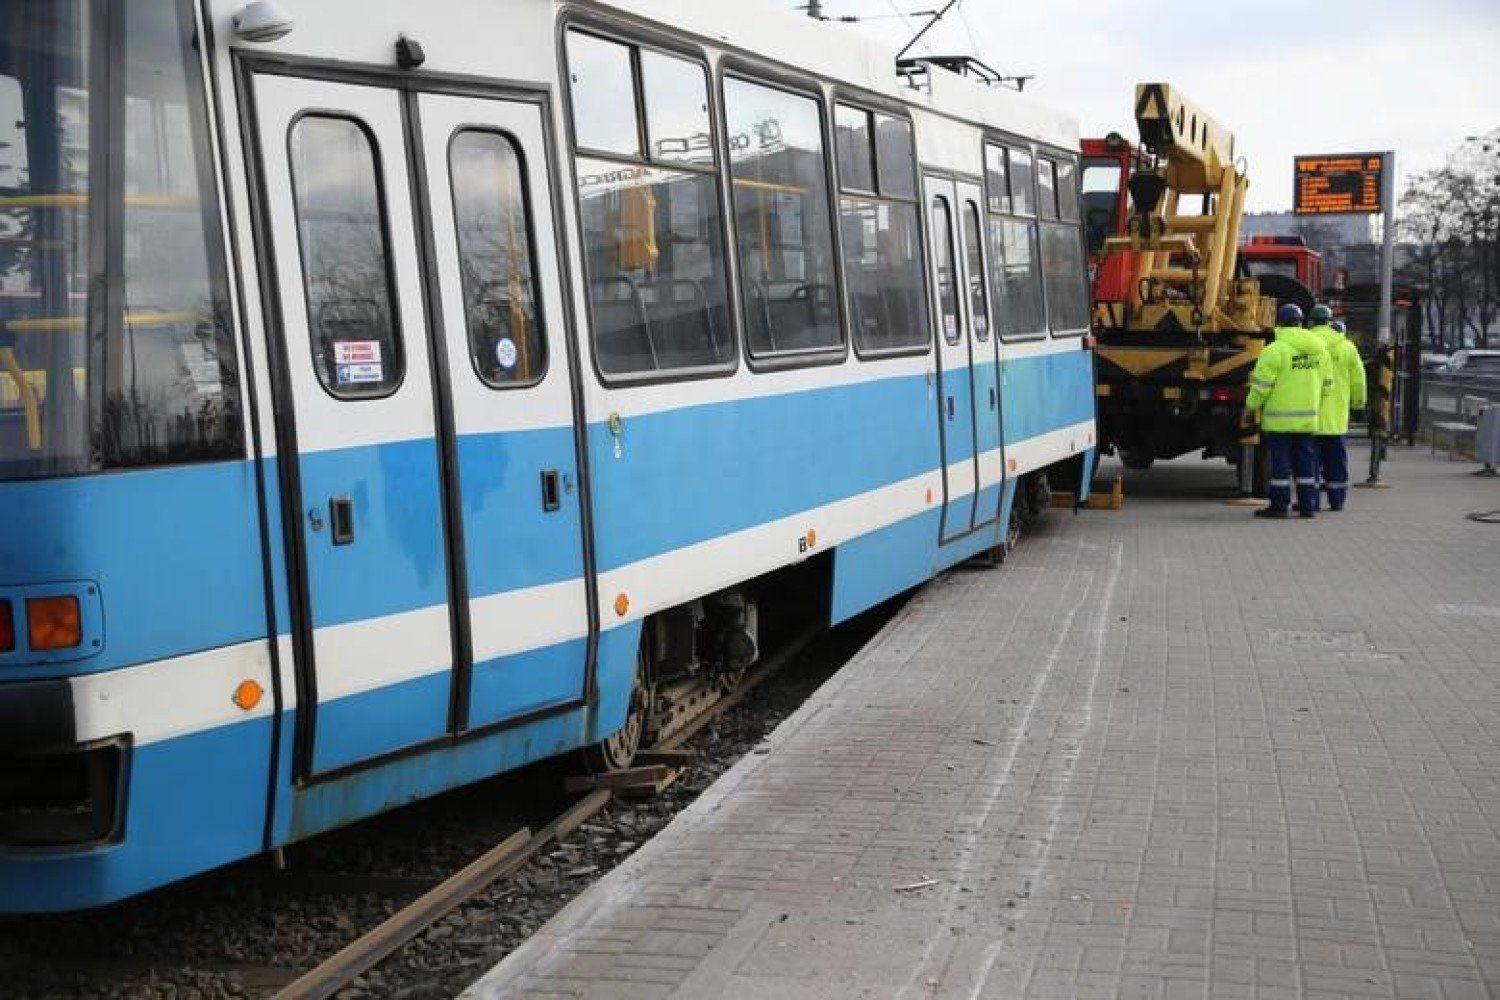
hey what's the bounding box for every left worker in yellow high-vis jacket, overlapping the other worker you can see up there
[1245,303,1332,517]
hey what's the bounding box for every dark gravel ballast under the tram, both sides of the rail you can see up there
[0,607,894,1000]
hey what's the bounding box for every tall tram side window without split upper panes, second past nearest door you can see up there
[725,76,843,357]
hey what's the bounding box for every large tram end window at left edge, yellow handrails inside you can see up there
[0,0,242,480]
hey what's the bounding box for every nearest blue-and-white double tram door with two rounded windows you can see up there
[252,73,588,778]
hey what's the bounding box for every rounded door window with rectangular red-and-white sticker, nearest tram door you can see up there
[291,114,405,399]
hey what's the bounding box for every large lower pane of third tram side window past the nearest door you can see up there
[839,195,930,354]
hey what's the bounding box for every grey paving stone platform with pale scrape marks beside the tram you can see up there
[465,453,1500,1000]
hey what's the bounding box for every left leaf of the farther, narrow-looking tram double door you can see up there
[924,175,978,541]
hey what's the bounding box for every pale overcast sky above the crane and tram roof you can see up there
[779,0,1500,211]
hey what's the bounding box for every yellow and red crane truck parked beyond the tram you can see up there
[1082,82,1320,495]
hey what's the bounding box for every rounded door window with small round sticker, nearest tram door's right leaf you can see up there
[449,129,548,388]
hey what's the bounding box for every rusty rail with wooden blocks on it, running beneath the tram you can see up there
[275,627,824,1000]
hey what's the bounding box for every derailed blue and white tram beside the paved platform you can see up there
[0,0,1094,912]
